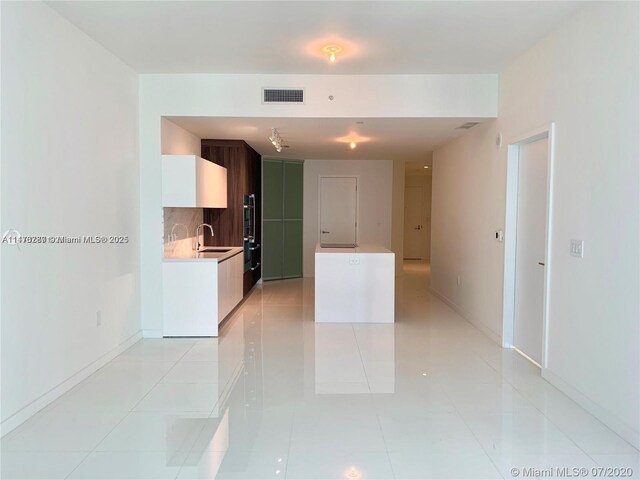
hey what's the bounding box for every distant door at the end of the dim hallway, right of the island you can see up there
[404,186,427,259]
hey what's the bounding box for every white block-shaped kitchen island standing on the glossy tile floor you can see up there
[315,244,395,323]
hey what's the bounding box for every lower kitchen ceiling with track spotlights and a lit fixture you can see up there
[167,117,486,165]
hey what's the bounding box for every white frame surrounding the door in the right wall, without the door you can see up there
[502,122,555,369]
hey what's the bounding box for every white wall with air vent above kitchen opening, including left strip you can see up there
[139,74,498,336]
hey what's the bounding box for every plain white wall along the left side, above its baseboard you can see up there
[0,2,140,433]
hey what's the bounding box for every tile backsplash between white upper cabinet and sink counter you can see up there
[162,207,202,257]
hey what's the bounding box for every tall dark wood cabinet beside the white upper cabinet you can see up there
[201,140,262,294]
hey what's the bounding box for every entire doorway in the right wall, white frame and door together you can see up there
[502,124,554,369]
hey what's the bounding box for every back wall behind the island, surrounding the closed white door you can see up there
[302,160,393,276]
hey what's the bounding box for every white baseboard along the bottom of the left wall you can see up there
[0,330,142,436]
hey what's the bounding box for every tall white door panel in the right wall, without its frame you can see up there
[513,138,549,365]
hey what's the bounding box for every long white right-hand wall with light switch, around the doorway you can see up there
[432,2,640,447]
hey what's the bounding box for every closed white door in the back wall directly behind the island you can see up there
[320,177,358,244]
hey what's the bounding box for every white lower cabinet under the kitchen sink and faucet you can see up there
[162,253,244,337]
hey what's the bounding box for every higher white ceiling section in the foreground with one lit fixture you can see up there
[49,0,583,74]
